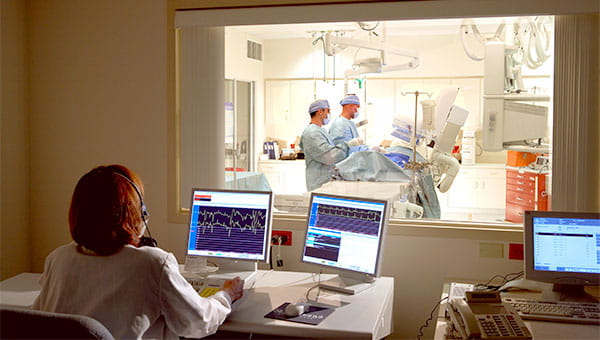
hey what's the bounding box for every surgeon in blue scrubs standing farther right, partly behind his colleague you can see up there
[329,94,369,153]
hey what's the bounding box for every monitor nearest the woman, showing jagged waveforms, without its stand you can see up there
[187,189,272,261]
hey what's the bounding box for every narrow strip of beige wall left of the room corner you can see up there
[0,0,31,279]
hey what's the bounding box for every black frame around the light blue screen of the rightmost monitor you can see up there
[523,211,600,286]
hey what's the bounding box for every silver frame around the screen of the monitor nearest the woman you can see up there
[185,188,273,262]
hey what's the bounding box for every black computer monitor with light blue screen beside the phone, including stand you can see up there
[524,211,600,300]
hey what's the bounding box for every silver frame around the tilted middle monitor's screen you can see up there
[300,192,390,277]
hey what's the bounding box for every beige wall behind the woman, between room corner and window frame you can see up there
[28,0,170,272]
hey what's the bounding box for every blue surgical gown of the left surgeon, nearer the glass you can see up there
[300,124,348,191]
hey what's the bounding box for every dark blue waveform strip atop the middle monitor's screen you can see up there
[315,204,382,236]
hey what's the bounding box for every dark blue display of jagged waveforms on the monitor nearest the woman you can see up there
[195,207,267,254]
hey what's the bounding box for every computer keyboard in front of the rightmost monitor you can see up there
[502,298,600,325]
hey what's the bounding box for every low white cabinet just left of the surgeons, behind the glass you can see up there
[258,160,306,195]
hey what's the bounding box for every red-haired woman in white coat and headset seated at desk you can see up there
[33,165,242,339]
